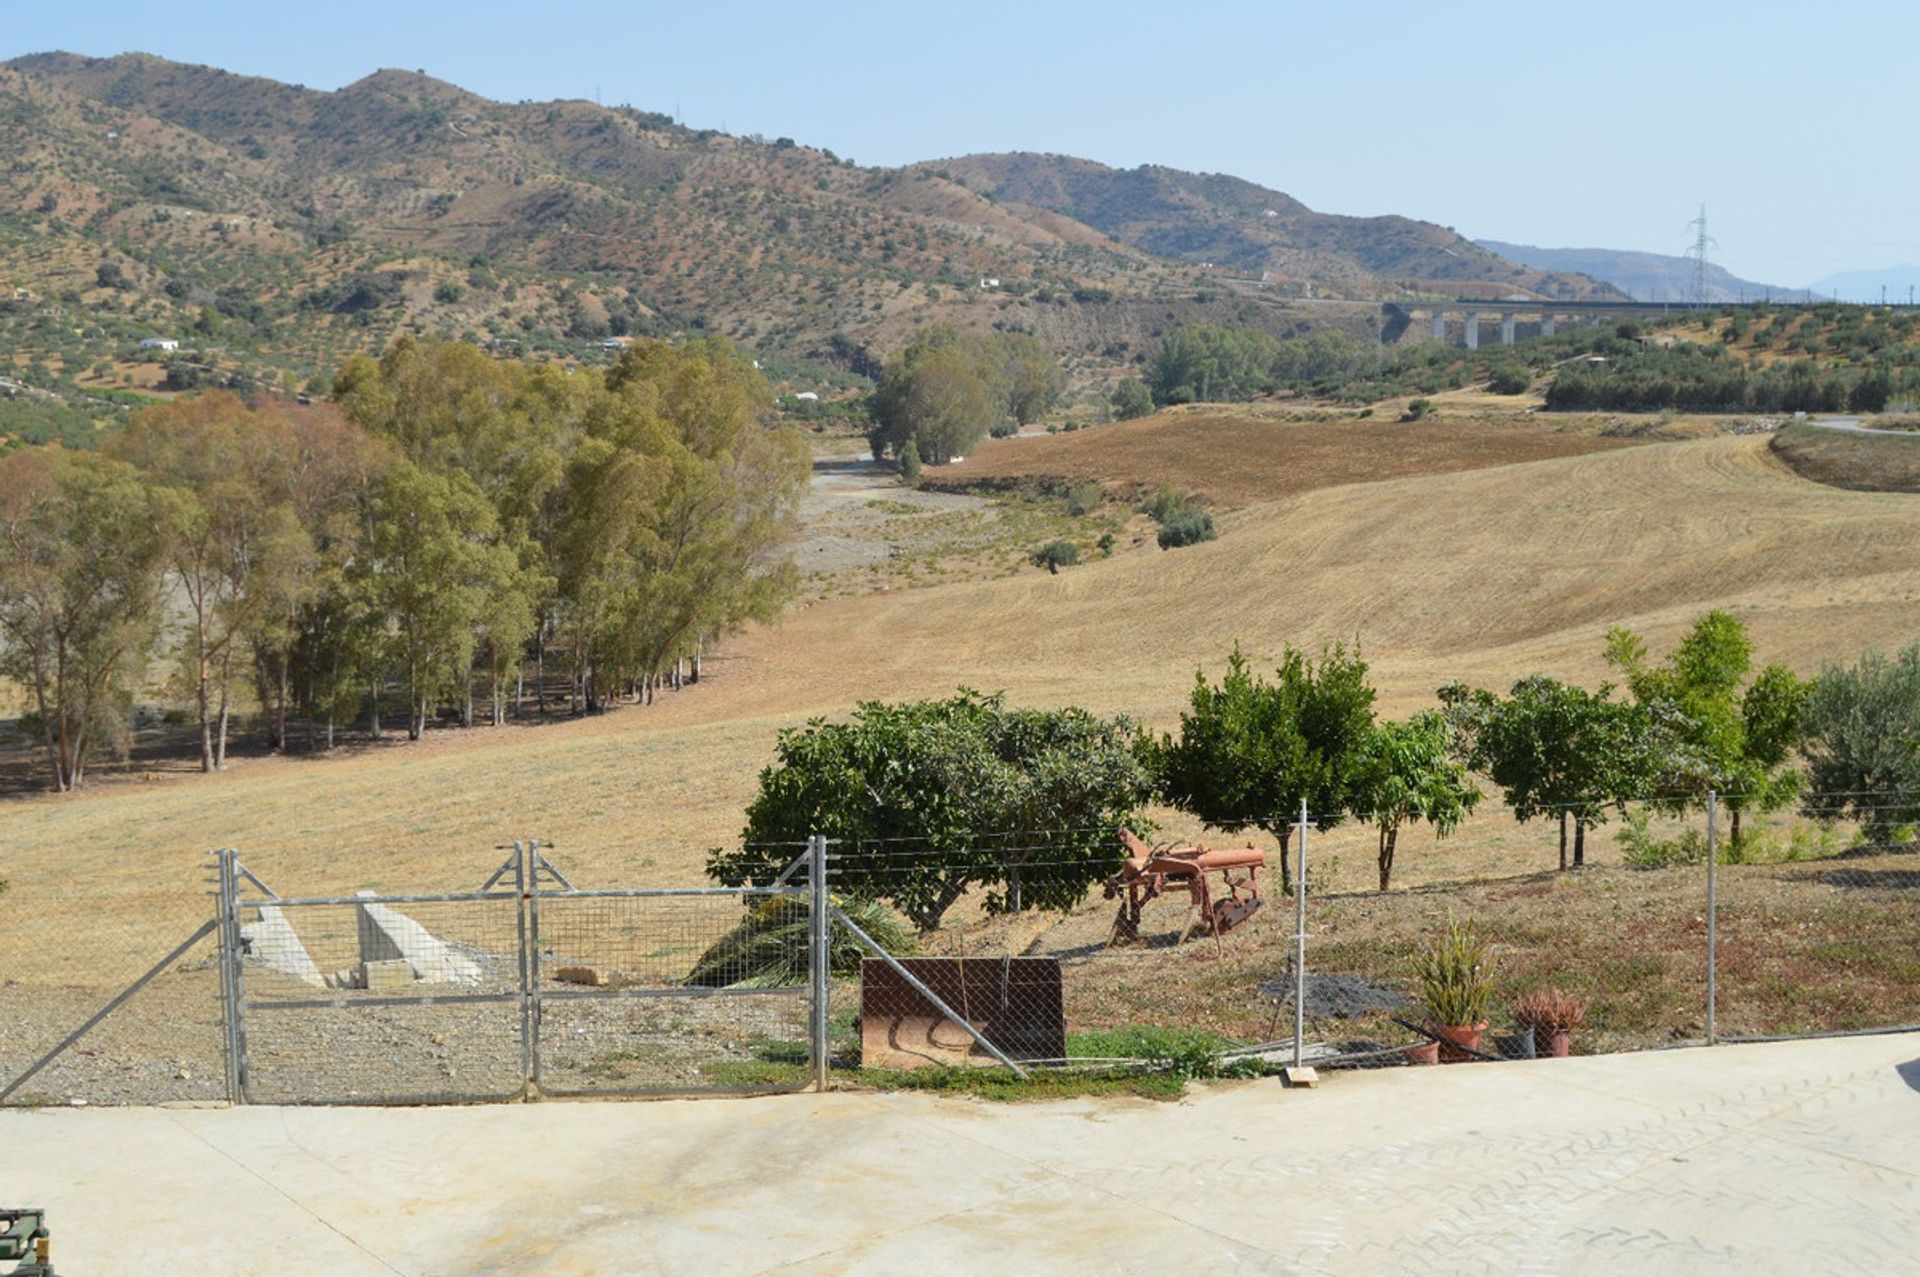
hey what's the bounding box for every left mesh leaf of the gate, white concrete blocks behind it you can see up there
[240,893,526,1104]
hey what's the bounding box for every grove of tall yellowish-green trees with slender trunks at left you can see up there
[0,338,806,789]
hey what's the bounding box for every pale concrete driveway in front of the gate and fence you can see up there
[15,1035,1920,1277]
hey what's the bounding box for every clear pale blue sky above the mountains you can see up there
[0,0,1920,286]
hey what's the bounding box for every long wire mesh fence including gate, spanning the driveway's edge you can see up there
[11,795,1920,1104]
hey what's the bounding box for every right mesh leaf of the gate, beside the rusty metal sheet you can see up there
[536,889,812,1095]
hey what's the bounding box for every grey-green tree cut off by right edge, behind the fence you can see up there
[1801,643,1920,843]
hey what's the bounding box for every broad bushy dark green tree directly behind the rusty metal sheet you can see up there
[707,689,1154,929]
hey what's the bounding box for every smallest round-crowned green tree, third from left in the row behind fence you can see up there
[1352,711,1480,891]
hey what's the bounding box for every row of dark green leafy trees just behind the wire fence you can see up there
[708,611,1920,928]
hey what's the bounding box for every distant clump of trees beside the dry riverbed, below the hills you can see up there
[868,325,1066,465]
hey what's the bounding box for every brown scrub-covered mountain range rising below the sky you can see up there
[0,54,1617,393]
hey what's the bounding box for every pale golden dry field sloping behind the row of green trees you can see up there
[0,424,1920,1067]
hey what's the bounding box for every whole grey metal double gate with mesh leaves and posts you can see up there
[217,841,826,1104]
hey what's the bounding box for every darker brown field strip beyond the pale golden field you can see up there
[925,411,1630,509]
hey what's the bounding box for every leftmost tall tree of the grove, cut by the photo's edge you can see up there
[0,449,165,791]
